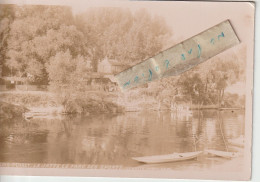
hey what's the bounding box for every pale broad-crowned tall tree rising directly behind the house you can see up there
[76,8,171,71]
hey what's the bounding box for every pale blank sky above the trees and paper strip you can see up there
[1,0,254,42]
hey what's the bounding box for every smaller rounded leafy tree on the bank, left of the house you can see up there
[46,49,91,111]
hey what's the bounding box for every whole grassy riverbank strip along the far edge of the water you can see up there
[0,91,243,117]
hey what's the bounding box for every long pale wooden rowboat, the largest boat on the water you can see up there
[132,151,202,164]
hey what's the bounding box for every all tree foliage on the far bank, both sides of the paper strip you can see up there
[0,5,246,111]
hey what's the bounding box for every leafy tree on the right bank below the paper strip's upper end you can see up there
[175,46,246,107]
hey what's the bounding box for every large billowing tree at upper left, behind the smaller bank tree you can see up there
[5,6,76,81]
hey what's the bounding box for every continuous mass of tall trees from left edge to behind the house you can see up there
[0,5,173,83]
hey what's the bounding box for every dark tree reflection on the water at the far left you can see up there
[0,118,49,162]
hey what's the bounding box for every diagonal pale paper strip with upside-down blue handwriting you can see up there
[115,20,239,90]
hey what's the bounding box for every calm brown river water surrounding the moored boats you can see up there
[0,110,244,171]
